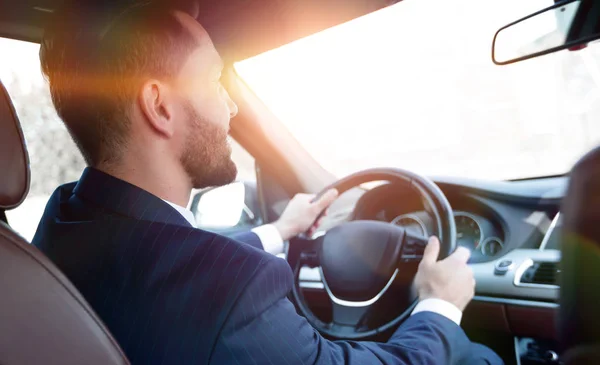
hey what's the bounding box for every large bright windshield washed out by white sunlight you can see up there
[236,0,600,180]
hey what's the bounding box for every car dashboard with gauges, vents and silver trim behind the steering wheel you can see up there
[298,177,568,344]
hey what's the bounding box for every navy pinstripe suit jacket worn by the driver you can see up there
[33,168,470,365]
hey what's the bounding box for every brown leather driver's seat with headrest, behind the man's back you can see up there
[0,78,128,365]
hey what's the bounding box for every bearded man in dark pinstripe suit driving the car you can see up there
[33,3,502,364]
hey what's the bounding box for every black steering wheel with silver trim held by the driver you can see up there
[288,168,456,339]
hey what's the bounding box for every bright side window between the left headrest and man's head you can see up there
[0,38,85,241]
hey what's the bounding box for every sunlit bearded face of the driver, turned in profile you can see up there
[170,12,237,189]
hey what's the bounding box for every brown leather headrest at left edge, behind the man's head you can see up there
[0,81,30,210]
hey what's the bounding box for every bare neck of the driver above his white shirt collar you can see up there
[94,164,192,207]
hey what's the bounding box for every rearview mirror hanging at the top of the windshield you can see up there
[492,0,598,65]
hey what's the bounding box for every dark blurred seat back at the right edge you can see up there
[559,148,600,356]
